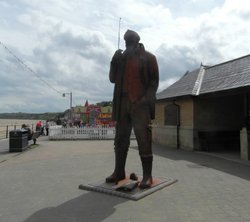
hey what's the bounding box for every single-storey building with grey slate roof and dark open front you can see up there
[153,55,250,160]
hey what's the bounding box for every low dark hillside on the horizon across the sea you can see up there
[0,112,64,120]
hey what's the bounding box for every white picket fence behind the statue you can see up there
[49,126,135,140]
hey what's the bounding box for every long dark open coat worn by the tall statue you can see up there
[109,43,159,121]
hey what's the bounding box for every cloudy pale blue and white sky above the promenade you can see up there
[0,0,250,113]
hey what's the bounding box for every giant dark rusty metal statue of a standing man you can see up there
[106,30,159,188]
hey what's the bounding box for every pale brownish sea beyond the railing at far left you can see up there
[0,119,45,139]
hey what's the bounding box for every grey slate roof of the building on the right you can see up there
[156,55,250,100]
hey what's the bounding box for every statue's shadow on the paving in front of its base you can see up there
[24,192,126,222]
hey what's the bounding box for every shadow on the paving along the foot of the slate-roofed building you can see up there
[132,144,250,181]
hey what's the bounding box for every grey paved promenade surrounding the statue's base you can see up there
[0,137,250,222]
